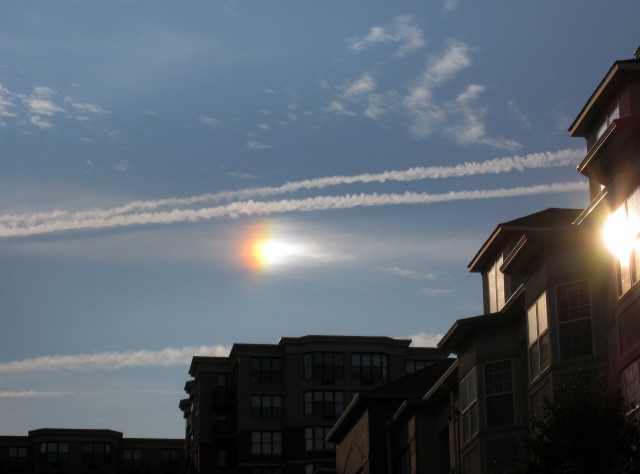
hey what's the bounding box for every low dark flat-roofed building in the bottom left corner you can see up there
[0,428,185,474]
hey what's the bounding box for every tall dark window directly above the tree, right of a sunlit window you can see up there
[556,280,593,360]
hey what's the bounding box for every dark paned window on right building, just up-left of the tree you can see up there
[484,360,515,428]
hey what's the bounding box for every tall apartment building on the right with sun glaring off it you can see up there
[328,50,640,474]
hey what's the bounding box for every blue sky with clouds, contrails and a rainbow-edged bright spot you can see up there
[0,0,640,438]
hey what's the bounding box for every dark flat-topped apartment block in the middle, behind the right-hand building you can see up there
[180,336,444,474]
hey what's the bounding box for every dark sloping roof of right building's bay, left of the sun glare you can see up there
[468,207,582,272]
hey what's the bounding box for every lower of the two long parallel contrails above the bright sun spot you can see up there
[0,181,587,238]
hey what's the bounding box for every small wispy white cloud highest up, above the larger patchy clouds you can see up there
[350,15,425,57]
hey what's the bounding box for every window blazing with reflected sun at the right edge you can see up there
[605,188,640,296]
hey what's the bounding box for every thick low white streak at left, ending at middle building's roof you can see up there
[0,345,230,374]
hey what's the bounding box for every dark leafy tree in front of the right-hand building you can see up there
[522,372,640,474]
